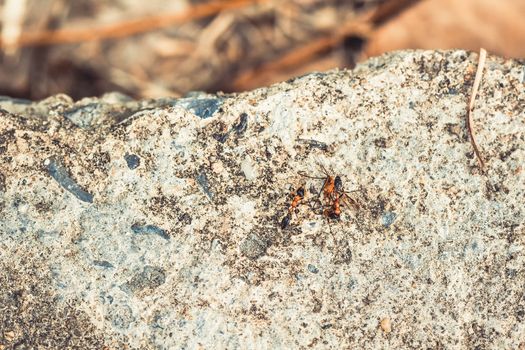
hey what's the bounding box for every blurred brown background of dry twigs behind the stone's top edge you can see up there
[0,0,525,99]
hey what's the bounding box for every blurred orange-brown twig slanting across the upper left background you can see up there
[0,0,268,47]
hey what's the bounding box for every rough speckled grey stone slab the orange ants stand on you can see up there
[0,51,525,349]
